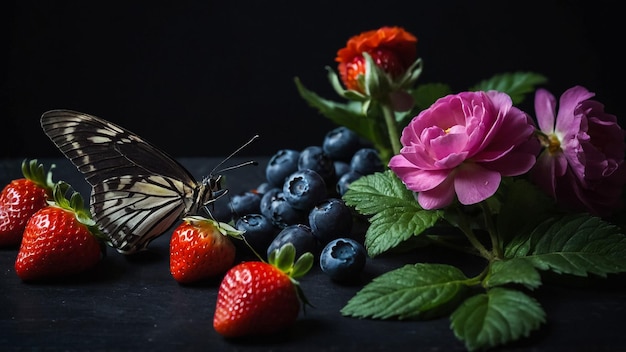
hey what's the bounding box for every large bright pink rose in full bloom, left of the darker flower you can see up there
[389,91,540,209]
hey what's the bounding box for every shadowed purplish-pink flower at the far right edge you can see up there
[531,86,626,216]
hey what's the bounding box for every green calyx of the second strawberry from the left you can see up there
[48,181,106,240]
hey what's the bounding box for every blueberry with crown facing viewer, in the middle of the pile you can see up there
[282,169,328,212]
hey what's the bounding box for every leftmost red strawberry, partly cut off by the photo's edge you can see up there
[0,160,54,247]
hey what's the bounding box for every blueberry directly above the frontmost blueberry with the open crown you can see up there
[309,198,352,245]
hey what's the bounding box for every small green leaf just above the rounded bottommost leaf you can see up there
[485,258,541,290]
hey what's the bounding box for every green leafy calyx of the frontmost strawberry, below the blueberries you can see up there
[267,242,314,310]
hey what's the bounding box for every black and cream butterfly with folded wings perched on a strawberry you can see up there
[41,110,258,254]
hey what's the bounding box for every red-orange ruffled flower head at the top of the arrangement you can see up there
[335,27,417,93]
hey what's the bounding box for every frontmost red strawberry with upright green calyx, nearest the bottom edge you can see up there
[213,243,313,337]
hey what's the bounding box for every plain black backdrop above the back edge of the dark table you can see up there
[0,0,624,158]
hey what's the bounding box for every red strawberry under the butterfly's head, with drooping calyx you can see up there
[170,216,241,283]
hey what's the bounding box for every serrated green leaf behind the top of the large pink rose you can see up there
[470,72,548,105]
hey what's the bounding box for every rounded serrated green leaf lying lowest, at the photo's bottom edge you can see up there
[450,287,546,351]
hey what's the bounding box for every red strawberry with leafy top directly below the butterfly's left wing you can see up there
[15,182,104,281]
